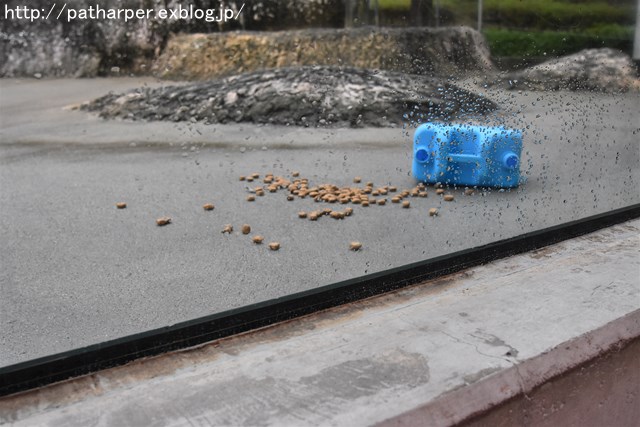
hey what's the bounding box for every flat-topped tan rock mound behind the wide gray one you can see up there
[154,27,494,80]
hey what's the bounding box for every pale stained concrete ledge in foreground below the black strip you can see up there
[0,220,640,427]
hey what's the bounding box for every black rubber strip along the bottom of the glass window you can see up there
[0,204,640,396]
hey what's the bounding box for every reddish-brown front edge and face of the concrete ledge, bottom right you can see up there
[378,310,640,427]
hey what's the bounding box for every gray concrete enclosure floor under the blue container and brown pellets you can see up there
[0,79,640,366]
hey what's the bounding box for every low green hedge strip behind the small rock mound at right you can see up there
[483,24,633,58]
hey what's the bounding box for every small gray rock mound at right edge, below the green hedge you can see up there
[502,48,640,92]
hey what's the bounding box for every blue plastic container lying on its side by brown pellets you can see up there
[412,123,522,188]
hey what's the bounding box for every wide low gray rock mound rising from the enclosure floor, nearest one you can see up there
[82,67,497,127]
